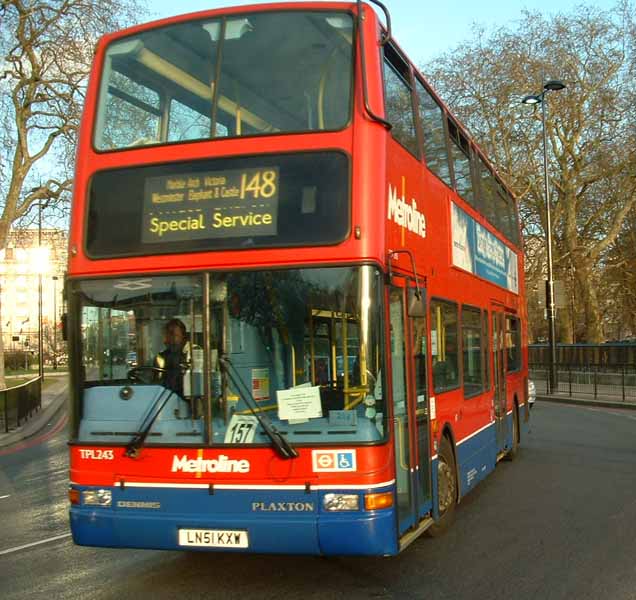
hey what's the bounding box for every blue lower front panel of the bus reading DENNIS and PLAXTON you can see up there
[70,485,398,556]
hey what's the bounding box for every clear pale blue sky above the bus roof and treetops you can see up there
[149,0,616,65]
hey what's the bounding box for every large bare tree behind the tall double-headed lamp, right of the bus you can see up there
[425,3,636,342]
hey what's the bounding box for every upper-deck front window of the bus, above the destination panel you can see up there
[94,11,353,151]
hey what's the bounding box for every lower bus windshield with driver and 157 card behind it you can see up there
[74,266,386,445]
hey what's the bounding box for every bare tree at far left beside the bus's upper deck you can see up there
[0,0,144,388]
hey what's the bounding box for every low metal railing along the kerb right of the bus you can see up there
[529,364,636,402]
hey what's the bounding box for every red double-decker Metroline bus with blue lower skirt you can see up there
[67,2,529,555]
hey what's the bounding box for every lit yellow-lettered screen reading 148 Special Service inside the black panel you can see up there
[141,167,280,244]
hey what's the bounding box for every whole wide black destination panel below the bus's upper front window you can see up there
[85,151,351,259]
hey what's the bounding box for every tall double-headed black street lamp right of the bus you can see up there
[521,79,565,394]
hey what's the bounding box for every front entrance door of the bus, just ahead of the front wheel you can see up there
[389,287,431,535]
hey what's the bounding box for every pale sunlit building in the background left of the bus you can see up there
[0,229,68,363]
